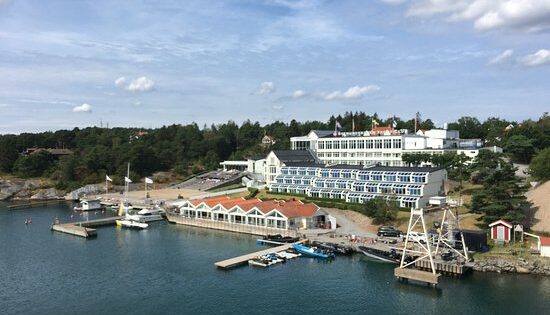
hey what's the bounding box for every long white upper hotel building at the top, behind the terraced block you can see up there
[290,127,482,166]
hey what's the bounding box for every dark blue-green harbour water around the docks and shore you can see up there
[0,205,550,315]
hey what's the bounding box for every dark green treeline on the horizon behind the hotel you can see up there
[0,112,550,189]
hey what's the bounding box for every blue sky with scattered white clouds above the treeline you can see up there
[0,0,550,134]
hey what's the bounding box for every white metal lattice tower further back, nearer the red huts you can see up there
[434,207,468,261]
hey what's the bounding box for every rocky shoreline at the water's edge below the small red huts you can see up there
[473,257,550,276]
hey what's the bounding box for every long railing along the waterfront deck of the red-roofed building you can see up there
[167,214,298,237]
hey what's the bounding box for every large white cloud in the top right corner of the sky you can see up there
[398,0,550,32]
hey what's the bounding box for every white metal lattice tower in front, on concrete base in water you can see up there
[399,208,436,275]
